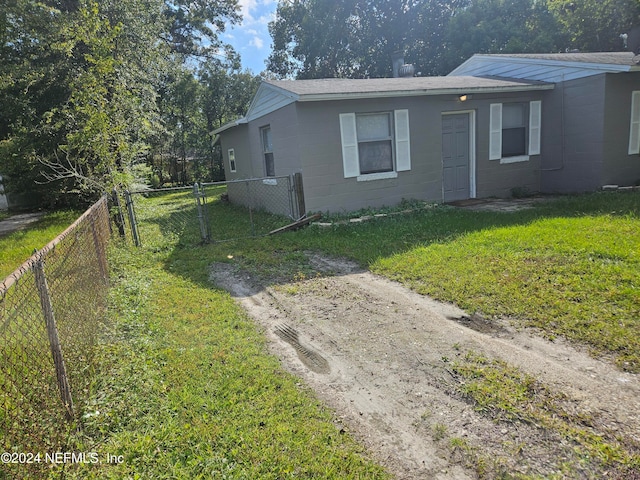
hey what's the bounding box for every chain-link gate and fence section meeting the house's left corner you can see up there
[126,176,304,247]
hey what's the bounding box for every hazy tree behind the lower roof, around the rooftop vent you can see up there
[268,0,468,78]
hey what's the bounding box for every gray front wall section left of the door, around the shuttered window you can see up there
[298,98,442,212]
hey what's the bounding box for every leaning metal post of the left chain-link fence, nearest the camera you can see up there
[34,258,73,420]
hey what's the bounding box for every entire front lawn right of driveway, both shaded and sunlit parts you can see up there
[191,192,640,372]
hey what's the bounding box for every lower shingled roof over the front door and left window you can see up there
[214,76,554,134]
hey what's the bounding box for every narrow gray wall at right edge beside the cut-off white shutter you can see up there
[600,72,640,186]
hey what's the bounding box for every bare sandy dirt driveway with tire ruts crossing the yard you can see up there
[211,254,640,480]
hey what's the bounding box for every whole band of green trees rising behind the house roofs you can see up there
[268,0,640,78]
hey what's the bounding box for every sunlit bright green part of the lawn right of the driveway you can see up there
[372,203,640,372]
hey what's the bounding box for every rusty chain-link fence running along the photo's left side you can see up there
[0,197,110,464]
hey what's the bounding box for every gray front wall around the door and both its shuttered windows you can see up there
[298,92,546,211]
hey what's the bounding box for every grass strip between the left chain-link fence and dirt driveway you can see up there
[60,240,388,479]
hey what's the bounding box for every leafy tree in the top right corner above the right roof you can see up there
[549,0,640,52]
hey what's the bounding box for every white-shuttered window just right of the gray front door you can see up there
[489,100,542,163]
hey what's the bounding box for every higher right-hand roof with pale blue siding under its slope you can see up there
[449,52,640,82]
